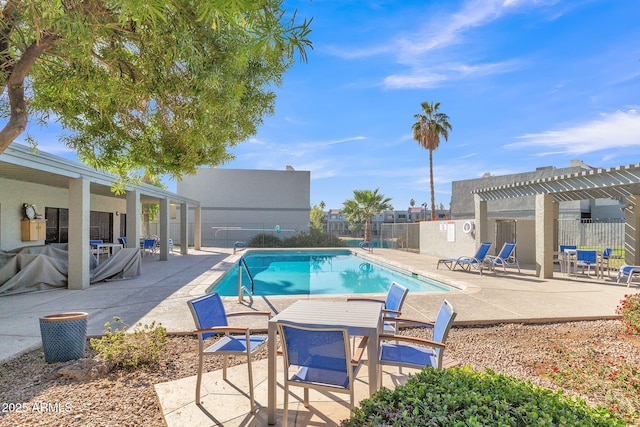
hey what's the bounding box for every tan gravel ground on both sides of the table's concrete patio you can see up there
[0,320,640,426]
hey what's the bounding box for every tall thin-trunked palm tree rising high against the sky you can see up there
[411,102,451,220]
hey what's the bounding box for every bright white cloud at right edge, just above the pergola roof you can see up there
[505,110,640,156]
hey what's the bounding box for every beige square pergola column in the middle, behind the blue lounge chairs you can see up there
[535,194,555,279]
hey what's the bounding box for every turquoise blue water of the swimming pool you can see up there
[211,250,451,296]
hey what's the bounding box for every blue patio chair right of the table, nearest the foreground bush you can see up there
[379,300,457,377]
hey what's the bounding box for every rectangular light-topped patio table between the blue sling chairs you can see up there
[267,300,382,424]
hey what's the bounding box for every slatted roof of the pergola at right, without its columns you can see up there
[472,163,640,202]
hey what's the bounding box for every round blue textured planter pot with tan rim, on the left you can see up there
[40,312,89,363]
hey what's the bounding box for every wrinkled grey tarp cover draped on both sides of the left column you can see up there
[0,245,142,295]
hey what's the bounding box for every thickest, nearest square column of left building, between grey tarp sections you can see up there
[67,178,91,290]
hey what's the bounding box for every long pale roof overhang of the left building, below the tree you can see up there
[0,143,200,206]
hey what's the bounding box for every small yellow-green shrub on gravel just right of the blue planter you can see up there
[89,316,167,369]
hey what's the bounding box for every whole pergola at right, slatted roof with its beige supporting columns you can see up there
[473,163,640,278]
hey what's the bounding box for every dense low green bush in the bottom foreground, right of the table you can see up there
[342,367,625,427]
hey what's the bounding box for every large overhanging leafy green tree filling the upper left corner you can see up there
[0,0,311,189]
